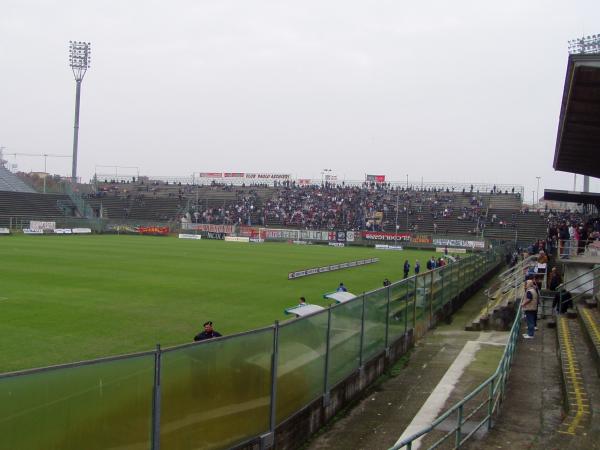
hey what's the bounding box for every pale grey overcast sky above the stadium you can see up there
[0,0,600,199]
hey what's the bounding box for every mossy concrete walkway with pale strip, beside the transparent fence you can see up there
[307,280,508,450]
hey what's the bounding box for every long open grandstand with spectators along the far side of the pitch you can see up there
[0,173,547,245]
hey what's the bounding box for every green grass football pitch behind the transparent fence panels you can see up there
[0,235,433,373]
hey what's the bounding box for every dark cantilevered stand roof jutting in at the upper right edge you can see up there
[553,54,600,177]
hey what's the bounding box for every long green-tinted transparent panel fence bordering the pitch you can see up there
[0,251,512,450]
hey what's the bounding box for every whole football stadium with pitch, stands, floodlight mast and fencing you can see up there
[0,5,600,450]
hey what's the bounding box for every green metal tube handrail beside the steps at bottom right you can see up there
[390,281,522,450]
